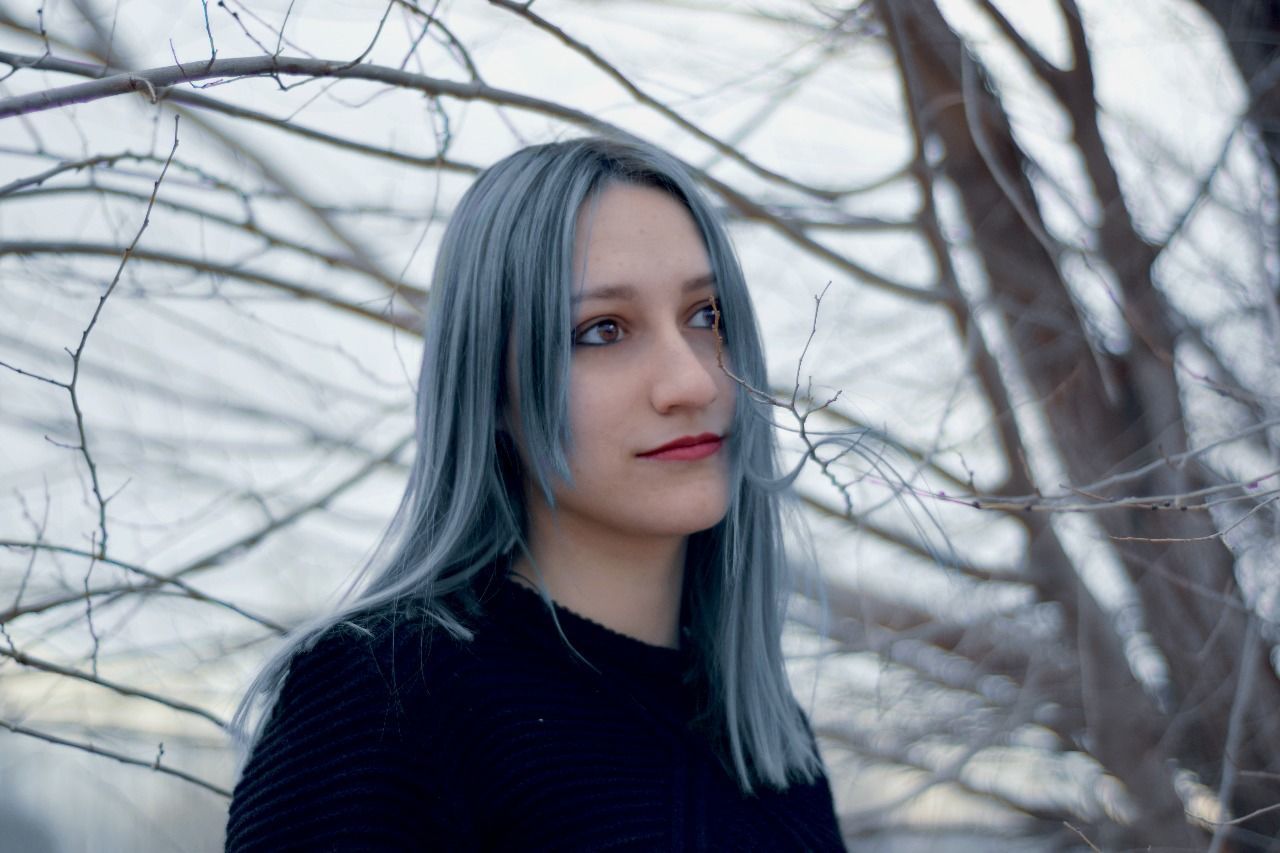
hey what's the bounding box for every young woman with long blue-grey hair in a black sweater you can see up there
[227,138,844,852]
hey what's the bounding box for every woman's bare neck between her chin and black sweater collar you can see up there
[512,506,687,648]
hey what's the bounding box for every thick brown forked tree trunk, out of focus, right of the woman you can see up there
[877,0,1280,848]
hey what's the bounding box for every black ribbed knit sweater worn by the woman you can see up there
[227,563,845,853]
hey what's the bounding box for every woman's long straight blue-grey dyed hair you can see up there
[232,137,820,793]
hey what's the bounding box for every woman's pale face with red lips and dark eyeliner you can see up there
[508,184,735,537]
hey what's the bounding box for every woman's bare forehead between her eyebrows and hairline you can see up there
[573,183,712,302]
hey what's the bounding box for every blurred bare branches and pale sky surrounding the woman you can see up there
[0,0,1280,853]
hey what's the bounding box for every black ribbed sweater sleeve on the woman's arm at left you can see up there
[225,628,468,853]
